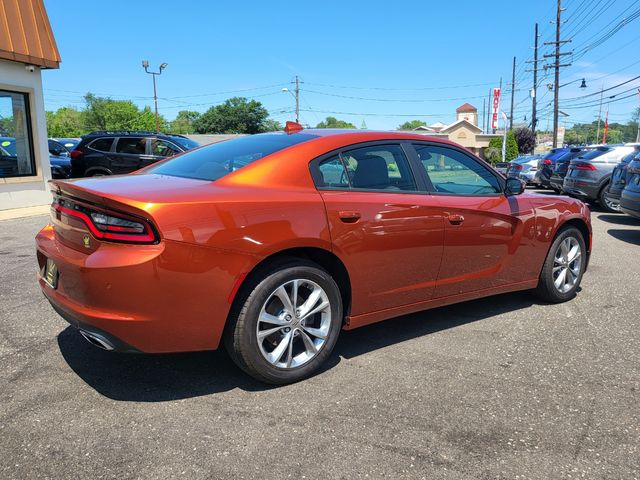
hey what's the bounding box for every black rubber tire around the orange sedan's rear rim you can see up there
[224,259,343,385]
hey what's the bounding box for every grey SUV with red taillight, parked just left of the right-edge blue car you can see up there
[562,145,634,212]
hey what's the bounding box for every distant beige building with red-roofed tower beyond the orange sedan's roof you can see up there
[400,103,501,158]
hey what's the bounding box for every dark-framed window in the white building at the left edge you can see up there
[0,90,36,178]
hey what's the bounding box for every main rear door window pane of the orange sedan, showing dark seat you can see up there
[341,145,416,191]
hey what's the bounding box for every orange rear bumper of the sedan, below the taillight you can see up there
[36,226,250,353]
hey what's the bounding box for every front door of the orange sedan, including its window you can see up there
[413,143,540,298]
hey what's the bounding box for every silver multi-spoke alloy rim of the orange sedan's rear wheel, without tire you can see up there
[256,279,331,369]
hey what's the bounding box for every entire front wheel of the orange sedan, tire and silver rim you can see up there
[535,227,587,303]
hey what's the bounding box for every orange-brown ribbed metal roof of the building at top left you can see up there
[0,0,60,68]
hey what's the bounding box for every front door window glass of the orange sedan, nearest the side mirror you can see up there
[414,145,502,195]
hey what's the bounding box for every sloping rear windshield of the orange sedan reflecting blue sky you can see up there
[147,133,317,181]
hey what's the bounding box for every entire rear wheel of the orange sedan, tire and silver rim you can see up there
[225,261,342,384]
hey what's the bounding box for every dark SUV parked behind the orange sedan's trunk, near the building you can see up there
[71,131,200,178]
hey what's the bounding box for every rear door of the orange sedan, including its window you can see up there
[312,143,444,316]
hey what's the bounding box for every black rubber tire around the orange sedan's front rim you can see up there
[534,226,587,303]
